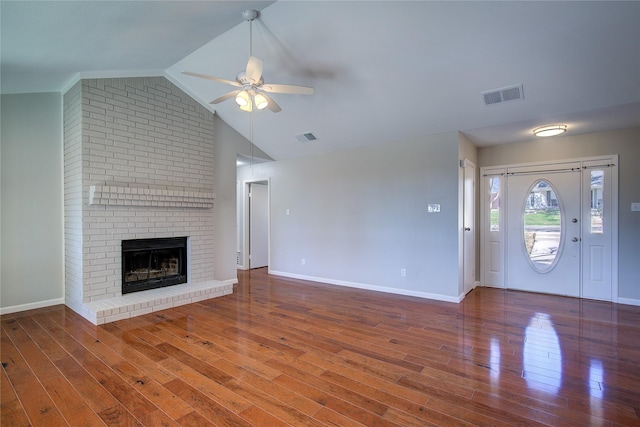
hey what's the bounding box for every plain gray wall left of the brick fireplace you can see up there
[0,93,64,313]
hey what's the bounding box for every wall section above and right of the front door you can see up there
[478,128,640,301]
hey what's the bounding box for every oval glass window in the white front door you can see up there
[522,179,562,273]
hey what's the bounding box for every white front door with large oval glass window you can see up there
[506,167,582,297]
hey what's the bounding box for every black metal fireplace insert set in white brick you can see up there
[122,237,187,294]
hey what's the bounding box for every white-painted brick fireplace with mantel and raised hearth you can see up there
[64,77,235,324]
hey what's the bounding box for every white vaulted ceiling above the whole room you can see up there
[0,0,640,159]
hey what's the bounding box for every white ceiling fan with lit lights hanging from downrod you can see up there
[182,9,313,113]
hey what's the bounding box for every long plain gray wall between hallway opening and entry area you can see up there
[239,132,460,301]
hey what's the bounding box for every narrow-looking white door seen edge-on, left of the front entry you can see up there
[463,160,476,295]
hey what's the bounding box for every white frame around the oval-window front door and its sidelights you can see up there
[480,154,619,302]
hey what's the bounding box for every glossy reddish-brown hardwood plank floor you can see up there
[0,269,640,426]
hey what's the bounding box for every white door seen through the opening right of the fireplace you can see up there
[249,182,269,268]
